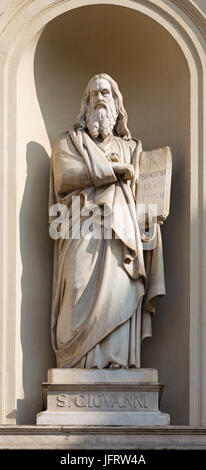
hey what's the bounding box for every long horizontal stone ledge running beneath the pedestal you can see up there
[0,425,206,450]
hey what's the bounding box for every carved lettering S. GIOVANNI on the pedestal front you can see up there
[56,393,148,410]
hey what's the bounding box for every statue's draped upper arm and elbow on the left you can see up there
[52,134,92,194]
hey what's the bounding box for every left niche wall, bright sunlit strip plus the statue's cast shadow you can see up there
[16,33,54,424]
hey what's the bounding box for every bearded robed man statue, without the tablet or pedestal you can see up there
[49,73,165,369]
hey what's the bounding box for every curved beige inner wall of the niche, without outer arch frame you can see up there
[17,5,190,424]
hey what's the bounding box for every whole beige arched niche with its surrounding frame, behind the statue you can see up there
[2,1,204,424]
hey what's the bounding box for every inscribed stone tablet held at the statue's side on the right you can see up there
[137,147,172,220]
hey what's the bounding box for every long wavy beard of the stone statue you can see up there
[86,104,117,139]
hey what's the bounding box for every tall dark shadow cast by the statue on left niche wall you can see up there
[17,142,55,424]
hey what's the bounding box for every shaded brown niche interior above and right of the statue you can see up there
[32,5,190,424]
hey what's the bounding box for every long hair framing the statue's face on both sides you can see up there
[75,73,131,140]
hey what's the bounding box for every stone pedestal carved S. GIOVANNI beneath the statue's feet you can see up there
[37,369,170,426]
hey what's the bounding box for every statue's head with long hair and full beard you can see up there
[75,73,131,140]
